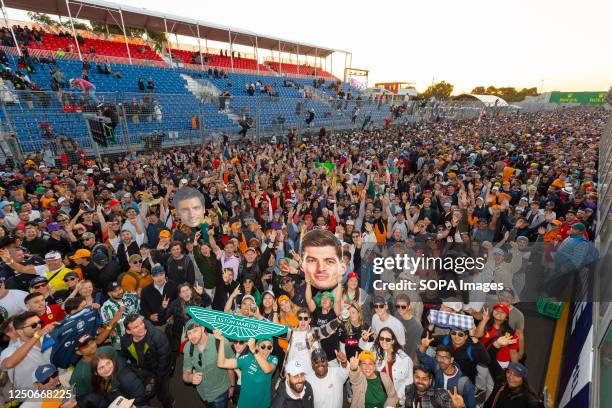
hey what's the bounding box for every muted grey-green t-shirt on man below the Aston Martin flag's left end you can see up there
[183,334,234,402]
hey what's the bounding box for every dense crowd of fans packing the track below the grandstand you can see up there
[0,108,606,408]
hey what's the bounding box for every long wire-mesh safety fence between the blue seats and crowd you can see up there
[0,85,516,159]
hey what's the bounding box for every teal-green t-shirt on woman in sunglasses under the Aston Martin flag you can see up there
[237,353,278,408]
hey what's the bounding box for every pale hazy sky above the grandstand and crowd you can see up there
[9,0,612,94]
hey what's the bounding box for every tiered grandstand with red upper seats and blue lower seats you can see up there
[0,0,378,152]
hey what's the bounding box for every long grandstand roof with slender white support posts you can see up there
[0,0,352,77]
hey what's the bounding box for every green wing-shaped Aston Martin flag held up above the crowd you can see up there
[185,306,287,341]
